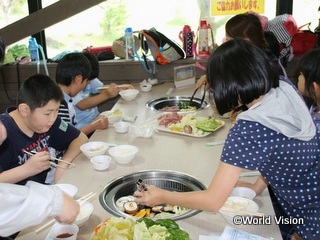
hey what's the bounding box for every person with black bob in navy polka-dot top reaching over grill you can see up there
[134,39,320,240]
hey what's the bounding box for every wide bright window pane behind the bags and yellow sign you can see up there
[43,0,276,57]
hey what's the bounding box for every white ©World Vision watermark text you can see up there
[233,215,304,225]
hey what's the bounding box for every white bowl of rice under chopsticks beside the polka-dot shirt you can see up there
[219,197,259,224]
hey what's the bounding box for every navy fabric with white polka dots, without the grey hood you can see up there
[221,120,320,239]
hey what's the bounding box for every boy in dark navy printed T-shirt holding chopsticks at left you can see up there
[0,74,88,184]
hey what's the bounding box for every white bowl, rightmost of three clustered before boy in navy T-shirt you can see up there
[109,145,139,164]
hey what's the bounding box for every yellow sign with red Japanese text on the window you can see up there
[210,0,264,17]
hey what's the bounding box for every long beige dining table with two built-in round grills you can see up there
[16,81,282,240]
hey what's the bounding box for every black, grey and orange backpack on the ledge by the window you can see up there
[139,28,186,65]
